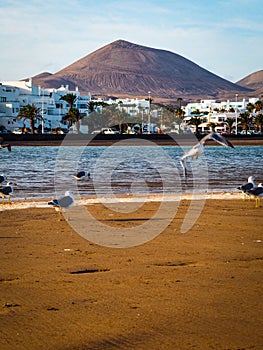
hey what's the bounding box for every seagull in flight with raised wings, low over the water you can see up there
[180,132,234,176]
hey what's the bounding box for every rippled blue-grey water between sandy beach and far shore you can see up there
[0,146,263,199]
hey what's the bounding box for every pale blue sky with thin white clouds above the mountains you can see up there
[0,0,263,82]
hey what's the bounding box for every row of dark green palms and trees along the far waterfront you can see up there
[11,93,263,134]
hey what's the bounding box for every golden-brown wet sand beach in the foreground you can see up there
[0,195,263,350]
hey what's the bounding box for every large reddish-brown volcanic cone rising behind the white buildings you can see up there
[33,40,251,100]
